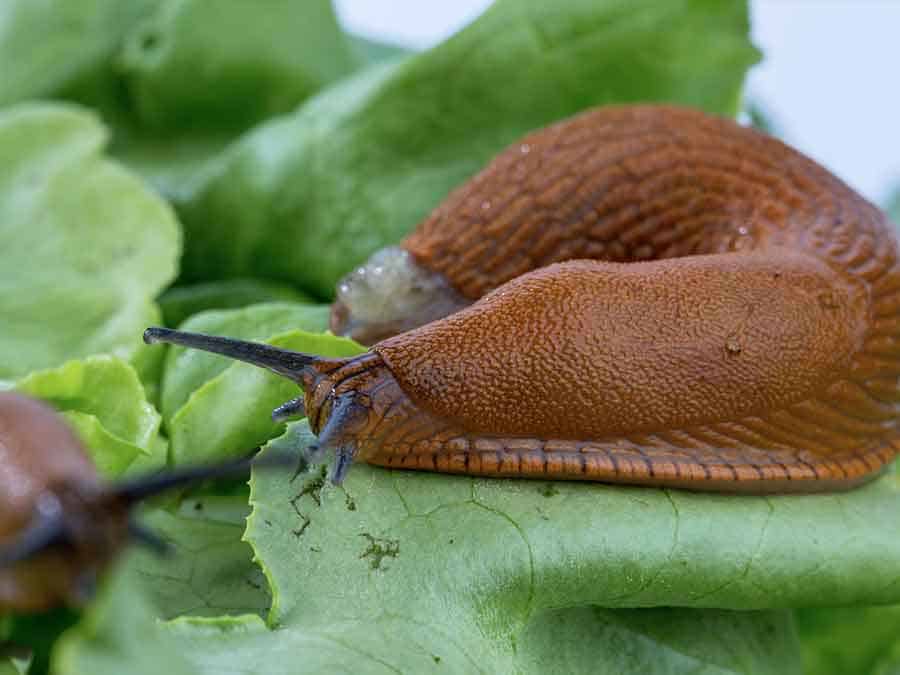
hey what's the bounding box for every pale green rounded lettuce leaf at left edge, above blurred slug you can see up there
[0,104,180,390]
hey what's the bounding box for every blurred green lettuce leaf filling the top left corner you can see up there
[0,0,361,194]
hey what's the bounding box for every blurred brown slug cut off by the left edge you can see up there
[0,392,285,612]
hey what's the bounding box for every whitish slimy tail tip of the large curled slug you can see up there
[331,246,470,345]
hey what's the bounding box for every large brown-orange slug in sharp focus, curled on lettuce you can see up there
[145,105,900,493]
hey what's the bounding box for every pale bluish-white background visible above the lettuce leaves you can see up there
[335,0,900,203]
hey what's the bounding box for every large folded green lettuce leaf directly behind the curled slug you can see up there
[179,0,757,297]
